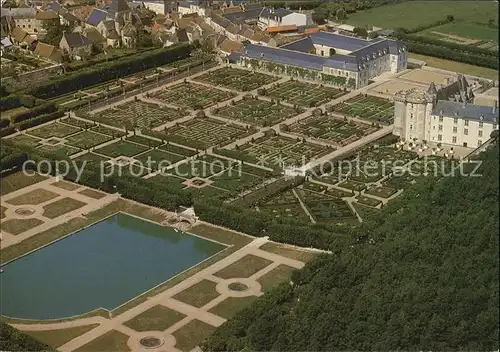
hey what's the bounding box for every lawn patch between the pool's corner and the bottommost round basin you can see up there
[123,304,186,332]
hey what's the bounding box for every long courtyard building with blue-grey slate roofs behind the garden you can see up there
[229,31,408,89]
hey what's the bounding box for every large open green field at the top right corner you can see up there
[345,1,498,29]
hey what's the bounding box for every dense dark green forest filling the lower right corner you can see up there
[203,144,499,351]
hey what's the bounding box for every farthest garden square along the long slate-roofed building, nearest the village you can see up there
[195,67,279,92]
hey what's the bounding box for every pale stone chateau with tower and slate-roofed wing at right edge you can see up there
[393,75,498,148]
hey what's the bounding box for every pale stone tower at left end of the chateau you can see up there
[392,88,437,141]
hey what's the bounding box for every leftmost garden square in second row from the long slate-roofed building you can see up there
[149,83,235,110]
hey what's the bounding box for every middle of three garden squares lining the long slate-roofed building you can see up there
[259,80,345,107]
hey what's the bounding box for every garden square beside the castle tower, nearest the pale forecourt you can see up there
[332,94,394,124]
